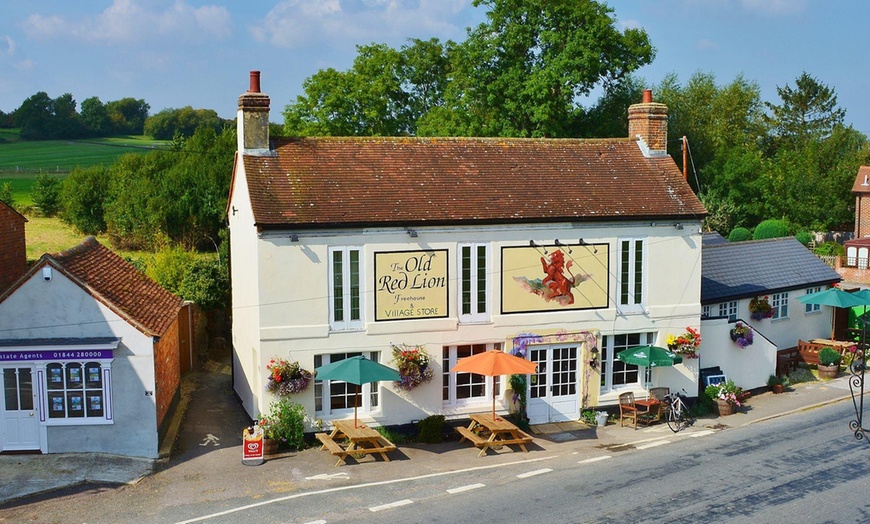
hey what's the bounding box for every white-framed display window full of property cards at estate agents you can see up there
[45,361,112,425]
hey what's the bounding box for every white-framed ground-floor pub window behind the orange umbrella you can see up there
[441,343,501,407]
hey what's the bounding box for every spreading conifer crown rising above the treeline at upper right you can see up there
[765,71,846,144]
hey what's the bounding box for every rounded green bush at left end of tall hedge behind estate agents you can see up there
[60,166,109,235]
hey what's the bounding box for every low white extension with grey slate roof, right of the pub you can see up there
[700,235,841,389]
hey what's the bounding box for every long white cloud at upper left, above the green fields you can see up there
[24,0,232,44]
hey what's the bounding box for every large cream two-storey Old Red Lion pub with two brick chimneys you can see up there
[227,72,706,425]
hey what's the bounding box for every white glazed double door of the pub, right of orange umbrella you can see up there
[526,345,579,424]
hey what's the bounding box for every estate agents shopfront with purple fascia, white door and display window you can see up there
[0,338,120,452]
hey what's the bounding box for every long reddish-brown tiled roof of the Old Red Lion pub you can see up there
[243,137,706,228]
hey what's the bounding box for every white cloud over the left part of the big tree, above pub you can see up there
[249,0,471,49]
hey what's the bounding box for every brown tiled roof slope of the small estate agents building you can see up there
[48,237,182,336]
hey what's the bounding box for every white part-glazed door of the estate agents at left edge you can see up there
[0,366,39,451]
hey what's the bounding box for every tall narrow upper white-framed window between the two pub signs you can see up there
[459,244,489,322]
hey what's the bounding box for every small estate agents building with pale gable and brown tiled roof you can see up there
[0,237,187,458]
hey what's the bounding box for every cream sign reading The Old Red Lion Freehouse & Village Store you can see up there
[375,249,447,321]
